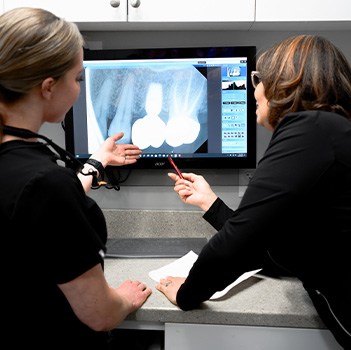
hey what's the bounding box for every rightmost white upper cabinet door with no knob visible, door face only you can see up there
[256,0,351,22]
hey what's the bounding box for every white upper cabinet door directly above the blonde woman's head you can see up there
[3,0,127,23]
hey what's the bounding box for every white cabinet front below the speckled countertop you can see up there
[165,323,342,350]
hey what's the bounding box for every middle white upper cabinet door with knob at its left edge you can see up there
[128,0,255,22]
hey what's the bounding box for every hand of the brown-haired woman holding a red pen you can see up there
[168,173,217,211]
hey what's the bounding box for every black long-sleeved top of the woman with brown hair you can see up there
[177,111,351,346]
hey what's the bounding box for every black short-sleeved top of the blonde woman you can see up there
[0,141,107,349]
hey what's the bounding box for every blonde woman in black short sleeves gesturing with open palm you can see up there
[0,8,151,349]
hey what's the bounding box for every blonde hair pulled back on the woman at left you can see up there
[0,7,84,103]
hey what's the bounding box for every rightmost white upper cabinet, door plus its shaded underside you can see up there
[253,0,351,30]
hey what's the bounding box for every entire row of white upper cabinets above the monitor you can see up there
[0,0,351,31]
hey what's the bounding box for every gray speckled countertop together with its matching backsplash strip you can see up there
[104,210,325,328]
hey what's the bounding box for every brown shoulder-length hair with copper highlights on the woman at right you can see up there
[257,35,351,128]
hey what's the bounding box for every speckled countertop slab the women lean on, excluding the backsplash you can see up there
[105,258,325,328]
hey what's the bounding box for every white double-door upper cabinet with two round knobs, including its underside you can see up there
[4,0,255,30]
